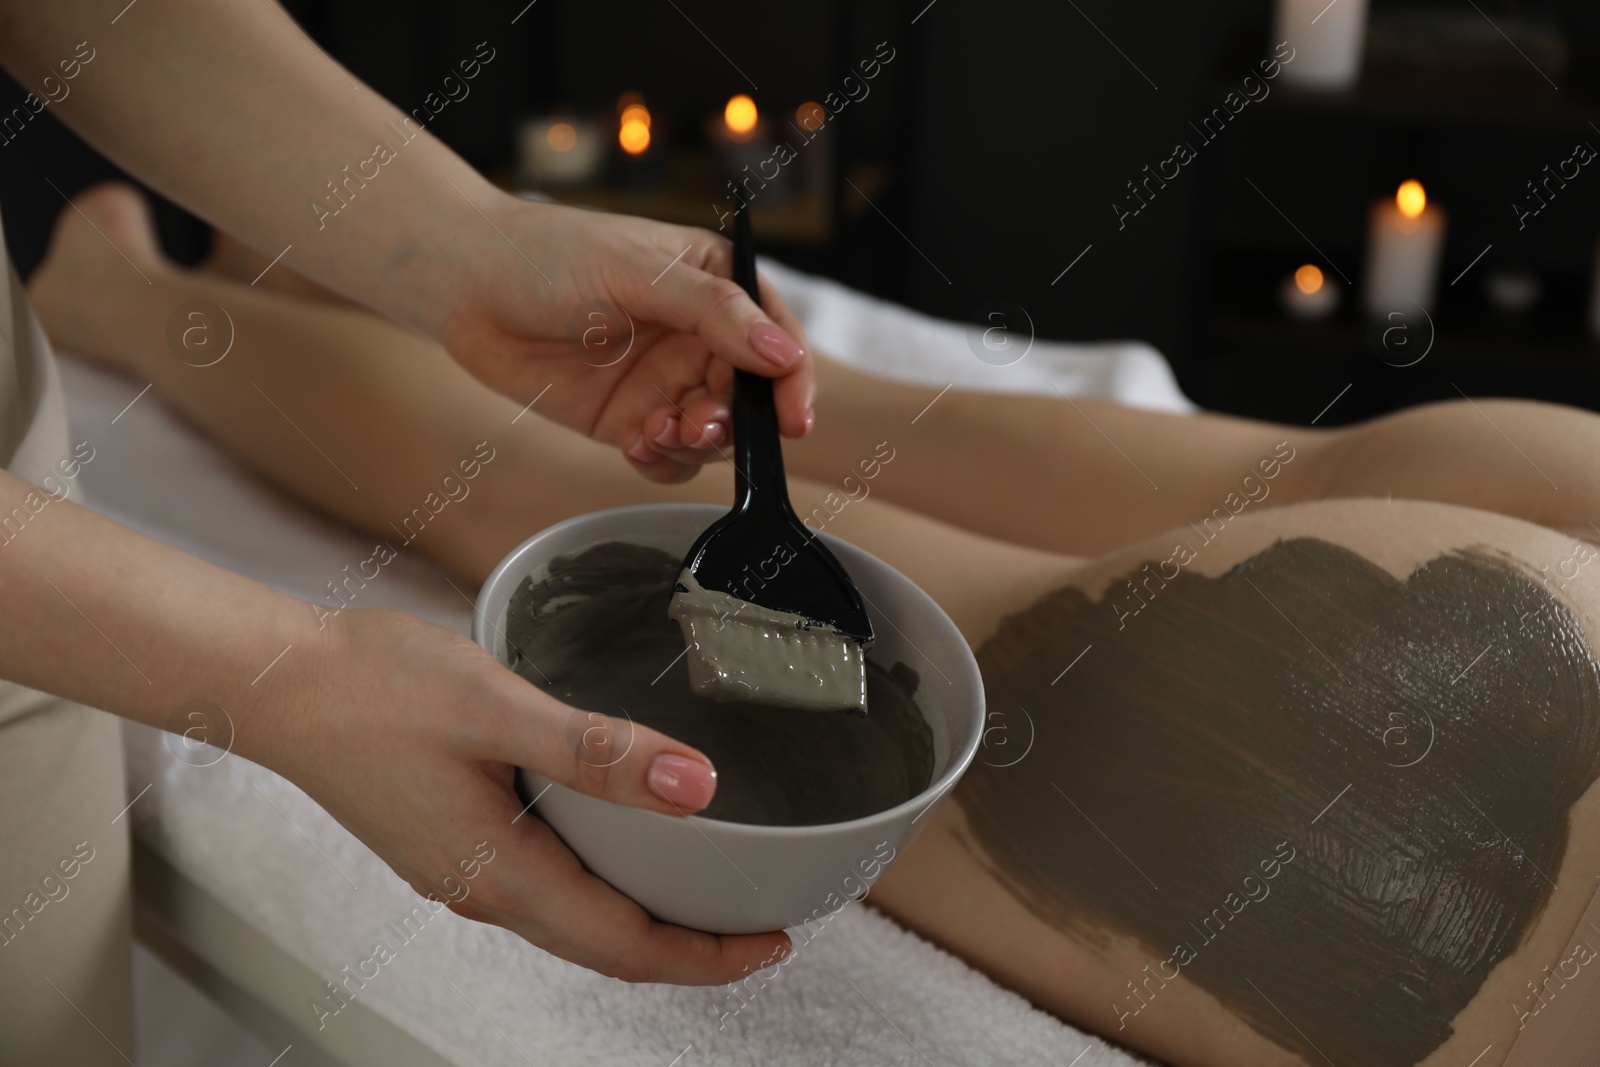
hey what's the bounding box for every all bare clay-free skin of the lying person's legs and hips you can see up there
[34,183,1600,1067]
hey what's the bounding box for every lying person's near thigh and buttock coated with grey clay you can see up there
[875,501,1600,1067]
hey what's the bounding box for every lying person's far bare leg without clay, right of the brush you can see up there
[787,360,1600,555]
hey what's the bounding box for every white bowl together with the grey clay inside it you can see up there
[474,504,984,934]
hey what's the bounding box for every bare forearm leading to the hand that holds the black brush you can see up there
[0,0,494,336]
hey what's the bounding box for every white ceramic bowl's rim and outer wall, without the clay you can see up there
[472,504,984,934]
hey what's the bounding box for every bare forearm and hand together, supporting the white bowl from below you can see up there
[0,472,787,984]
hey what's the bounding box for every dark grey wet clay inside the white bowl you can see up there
[504,542,933,825]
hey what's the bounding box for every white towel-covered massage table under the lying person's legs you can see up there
[61,262,1195,1067]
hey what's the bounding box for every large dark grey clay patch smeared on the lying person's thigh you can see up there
[957,537,1600,1065]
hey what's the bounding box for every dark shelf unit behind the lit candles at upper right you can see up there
[1184,28,1600,426]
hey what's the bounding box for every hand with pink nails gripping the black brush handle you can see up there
[440,195,816,482]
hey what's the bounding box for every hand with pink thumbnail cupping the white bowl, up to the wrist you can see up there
[246,609,789,985]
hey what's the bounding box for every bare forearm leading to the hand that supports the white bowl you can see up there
[0,472,318,758]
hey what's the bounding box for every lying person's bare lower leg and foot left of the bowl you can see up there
[29,189,731,584]
